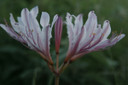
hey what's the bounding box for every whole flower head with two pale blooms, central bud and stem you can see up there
[0,6,125,80]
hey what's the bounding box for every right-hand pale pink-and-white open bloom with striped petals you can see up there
[65,11,125,62]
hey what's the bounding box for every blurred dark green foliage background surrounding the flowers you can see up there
[0,0,128,85]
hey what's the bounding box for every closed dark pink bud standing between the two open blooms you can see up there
[55,17,63,54]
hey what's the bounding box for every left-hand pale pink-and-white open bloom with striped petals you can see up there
[0,6,58,64]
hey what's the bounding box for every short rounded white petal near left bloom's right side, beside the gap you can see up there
[40,12,50,27]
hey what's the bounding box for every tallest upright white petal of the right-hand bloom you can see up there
[79,11,97,49]
